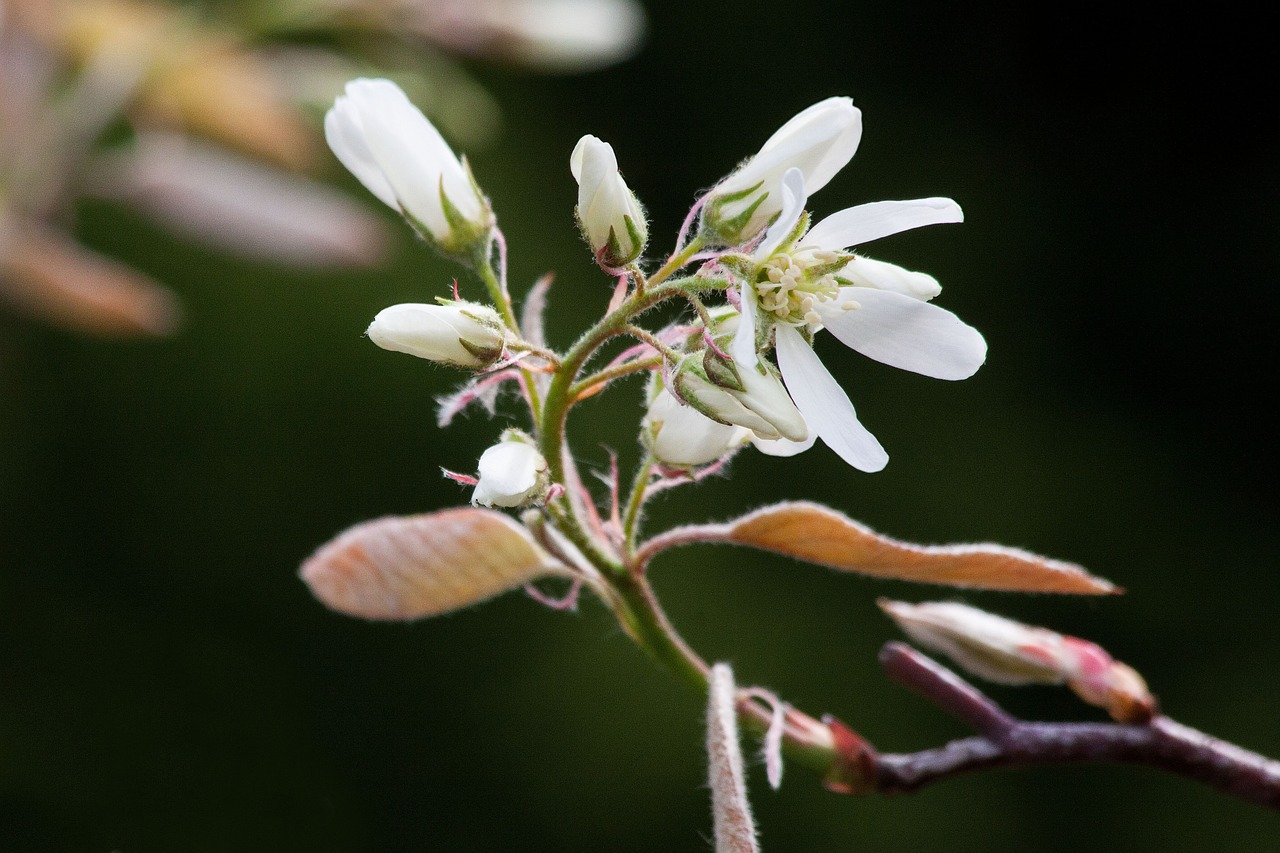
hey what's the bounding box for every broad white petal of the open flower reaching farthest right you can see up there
[822,287,987,379]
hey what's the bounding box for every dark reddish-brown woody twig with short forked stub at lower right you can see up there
[833,643,1280,809]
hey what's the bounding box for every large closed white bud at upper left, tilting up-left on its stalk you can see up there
[324,78,493,254]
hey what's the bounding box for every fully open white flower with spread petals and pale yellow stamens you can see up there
[731,169,987,471]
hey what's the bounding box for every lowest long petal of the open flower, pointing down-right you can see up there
[776,325,885,471]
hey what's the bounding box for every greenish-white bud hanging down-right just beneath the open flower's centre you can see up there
[675,351,809,442]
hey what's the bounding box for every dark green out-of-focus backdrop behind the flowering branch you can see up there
[0,0,1280,853]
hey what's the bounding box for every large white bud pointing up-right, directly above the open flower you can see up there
[703,97,863,245]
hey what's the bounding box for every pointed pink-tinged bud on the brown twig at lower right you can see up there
[878,599,1156,722]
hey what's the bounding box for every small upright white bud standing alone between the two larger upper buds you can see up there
[568,136,649,266]
